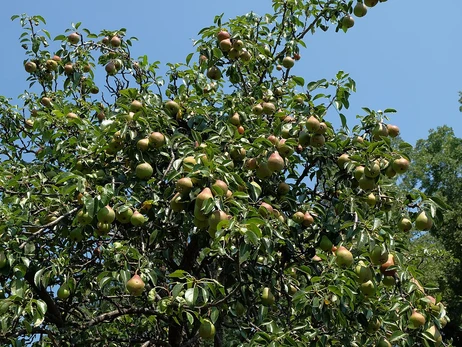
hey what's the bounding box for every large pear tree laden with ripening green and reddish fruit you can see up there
[0,0,452,346]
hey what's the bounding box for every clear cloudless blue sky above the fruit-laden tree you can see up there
[0,0,462,144]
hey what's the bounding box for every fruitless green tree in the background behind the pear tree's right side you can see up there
[404,126,462,344]
